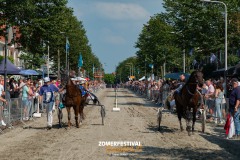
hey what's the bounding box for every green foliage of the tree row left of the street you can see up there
[0,0,101,75]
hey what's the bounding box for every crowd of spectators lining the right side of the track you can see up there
[124,75,240,137]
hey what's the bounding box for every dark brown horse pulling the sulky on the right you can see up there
[174,71,203,135]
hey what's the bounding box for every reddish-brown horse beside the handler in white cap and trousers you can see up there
[64,78,84,128]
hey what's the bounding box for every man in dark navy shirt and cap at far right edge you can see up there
[229,78,240,137]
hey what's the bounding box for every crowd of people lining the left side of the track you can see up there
[0,76,104,129]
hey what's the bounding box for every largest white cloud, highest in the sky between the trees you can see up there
[95,2,150,20]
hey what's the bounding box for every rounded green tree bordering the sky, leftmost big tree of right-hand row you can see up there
[135,14,180,75]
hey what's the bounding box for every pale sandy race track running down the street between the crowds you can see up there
[0,89,240,160]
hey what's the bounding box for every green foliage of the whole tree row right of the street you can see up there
[117,0,240,77]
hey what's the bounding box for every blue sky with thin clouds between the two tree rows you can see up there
[68,0,164,73]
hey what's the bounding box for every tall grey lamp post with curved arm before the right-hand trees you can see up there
[201,0,227,92]
